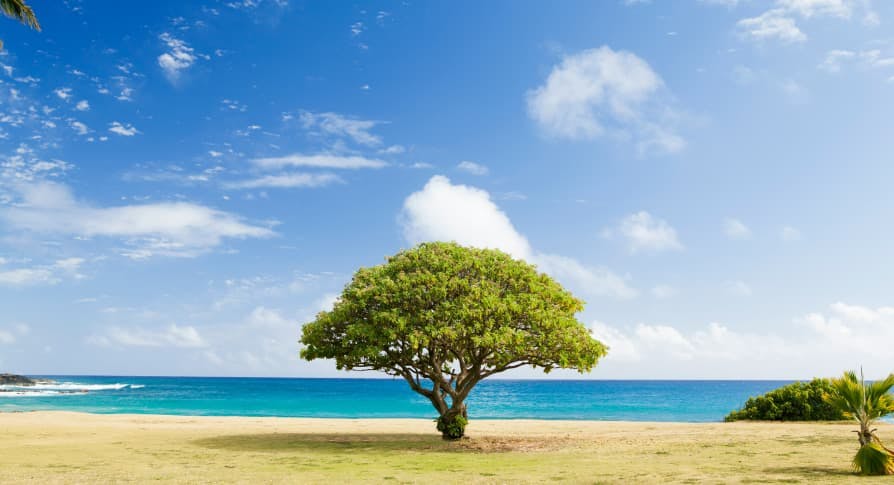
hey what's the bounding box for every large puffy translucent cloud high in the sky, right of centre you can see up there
[527,46,686,153]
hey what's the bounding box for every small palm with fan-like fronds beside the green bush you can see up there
[823,369,894,475]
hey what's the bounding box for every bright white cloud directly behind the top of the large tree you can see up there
[399,175,636,298]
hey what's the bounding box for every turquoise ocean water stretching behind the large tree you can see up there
[0,376,788,422]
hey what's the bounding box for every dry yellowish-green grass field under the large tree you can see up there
[0,412,894,484]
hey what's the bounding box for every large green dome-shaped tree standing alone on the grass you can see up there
[301,242,607,439]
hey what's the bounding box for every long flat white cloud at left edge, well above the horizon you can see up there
[0,183,274,258]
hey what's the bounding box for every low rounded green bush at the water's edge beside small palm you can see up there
[724,379,846,421]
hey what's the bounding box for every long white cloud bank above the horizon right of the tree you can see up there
[590,302,894,379]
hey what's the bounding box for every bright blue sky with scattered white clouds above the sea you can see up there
[0,0,894,379]
